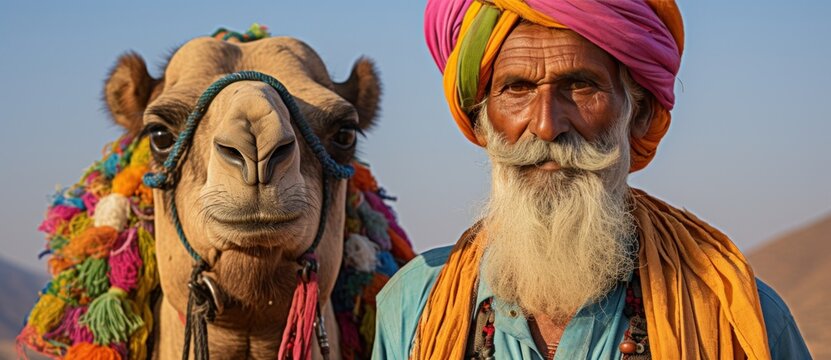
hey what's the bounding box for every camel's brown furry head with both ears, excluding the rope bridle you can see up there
[104,37,380,333]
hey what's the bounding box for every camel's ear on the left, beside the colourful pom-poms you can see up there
[104,52,159,135]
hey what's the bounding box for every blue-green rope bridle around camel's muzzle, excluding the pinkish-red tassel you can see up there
[143,71,355,359]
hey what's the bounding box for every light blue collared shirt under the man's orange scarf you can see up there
[372,246,811,360]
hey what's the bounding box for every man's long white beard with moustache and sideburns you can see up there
[477,100,636,320]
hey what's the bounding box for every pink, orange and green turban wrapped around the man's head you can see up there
[424,0,684,171]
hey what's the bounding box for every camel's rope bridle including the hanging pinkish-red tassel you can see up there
[143,71,354,360]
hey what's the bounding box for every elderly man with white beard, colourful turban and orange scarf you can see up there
[374,0,810,359]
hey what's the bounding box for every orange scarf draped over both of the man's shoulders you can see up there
[411,189,770,360]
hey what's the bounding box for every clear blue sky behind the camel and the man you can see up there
[0,0,831,271]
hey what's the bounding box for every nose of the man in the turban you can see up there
[528,86,571,141]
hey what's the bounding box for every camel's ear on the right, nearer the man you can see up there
[335,58,381,130]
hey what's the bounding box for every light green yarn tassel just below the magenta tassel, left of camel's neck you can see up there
[80,287,144,345]
